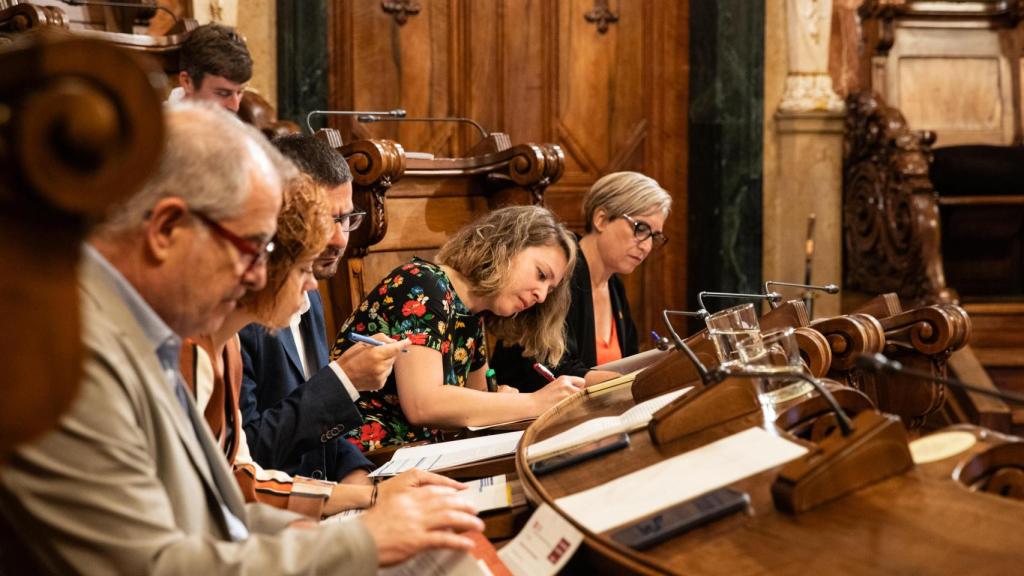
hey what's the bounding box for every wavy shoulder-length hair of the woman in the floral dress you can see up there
[437,206,577,364]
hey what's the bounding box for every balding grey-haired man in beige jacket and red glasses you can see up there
[0,100,482,574]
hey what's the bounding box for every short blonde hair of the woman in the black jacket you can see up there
[583,172,672,233]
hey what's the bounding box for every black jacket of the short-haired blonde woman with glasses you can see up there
[488,243,639,392]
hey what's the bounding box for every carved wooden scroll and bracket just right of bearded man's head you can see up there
[339,140,406,252]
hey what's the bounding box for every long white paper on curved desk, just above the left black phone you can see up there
[526,386,693,461]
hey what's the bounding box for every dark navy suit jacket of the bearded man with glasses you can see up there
[239,291,373,481]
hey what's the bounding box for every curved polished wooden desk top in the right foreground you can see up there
[516,387,1024,575]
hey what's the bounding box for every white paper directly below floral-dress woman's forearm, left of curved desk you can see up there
[370,430,522,478]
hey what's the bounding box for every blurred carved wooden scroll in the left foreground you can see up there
[0,32,164,461]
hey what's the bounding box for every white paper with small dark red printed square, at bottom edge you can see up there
[498,504,583,576]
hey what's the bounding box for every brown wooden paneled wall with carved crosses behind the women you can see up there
[328,0,689,345]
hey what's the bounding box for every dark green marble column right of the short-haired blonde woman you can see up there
[687,0,765,310]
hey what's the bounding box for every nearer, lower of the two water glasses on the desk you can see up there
[737,328,814,417]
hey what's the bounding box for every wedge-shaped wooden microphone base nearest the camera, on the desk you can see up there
[771,410,913,515]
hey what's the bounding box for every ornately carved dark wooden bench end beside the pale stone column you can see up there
[843,93,954,305]
